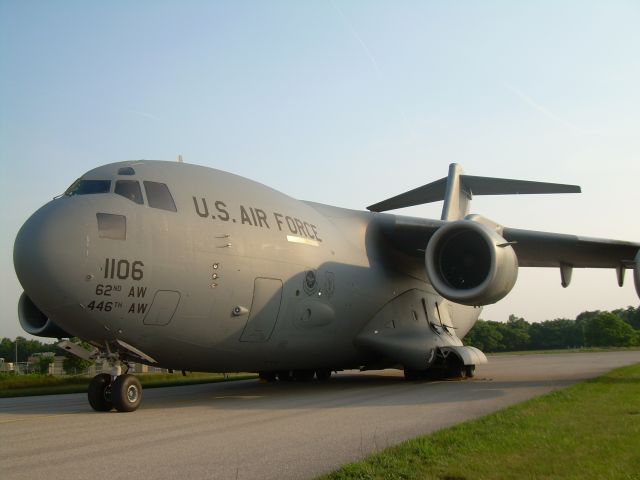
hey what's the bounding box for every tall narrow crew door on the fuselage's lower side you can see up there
[240,278,282,342]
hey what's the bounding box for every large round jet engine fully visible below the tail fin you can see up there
[425,220,518,306]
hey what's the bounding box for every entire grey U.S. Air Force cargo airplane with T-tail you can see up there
[14,161,640,411]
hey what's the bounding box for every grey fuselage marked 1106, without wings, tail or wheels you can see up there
[14,161,480,372]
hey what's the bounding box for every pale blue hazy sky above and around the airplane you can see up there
[0,0,640,337]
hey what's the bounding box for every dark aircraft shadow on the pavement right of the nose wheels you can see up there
[135,375,573,410]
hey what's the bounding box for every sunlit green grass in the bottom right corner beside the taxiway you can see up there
[322,364,640,480]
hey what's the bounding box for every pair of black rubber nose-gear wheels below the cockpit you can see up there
[88,365,142,412]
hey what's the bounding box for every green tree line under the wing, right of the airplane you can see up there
[464,307,640,353]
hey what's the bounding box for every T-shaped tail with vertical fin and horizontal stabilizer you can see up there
[367,163,581,220]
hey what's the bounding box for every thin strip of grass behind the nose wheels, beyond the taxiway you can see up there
[0,372,257,398]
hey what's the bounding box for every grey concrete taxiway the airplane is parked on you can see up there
[0,351,640,480]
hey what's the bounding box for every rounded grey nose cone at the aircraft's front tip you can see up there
[13,197,89,310]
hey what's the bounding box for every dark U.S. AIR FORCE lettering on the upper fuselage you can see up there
[192,197,322,242]
